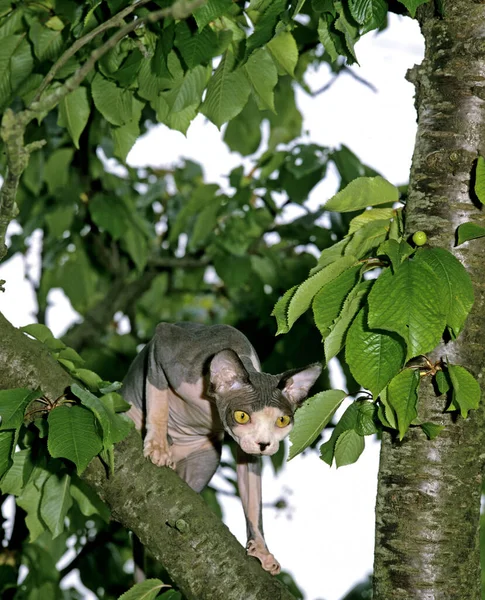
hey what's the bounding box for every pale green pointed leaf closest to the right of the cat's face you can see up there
[288,390,347,460]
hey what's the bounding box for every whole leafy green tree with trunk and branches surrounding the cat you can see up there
[0,0,485,599]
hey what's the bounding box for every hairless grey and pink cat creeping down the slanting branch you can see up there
[121,323,321,575]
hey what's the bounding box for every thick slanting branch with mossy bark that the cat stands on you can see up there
[0,314,294,600]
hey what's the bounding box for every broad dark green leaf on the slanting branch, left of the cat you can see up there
[47,406,103,474]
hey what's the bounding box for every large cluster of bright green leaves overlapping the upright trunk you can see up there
[273,177,480,466]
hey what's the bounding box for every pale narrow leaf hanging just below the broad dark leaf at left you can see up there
[39,473,72,538]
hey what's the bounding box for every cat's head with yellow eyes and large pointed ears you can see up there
[208,349,322,455]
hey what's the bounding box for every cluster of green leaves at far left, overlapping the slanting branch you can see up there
[0,324,133,560]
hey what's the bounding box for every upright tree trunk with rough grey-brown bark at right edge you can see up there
[374,0,485,600]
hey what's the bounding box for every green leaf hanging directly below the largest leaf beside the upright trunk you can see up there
[345,308,406,398]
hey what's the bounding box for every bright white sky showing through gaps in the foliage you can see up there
[0,15,424,600]
